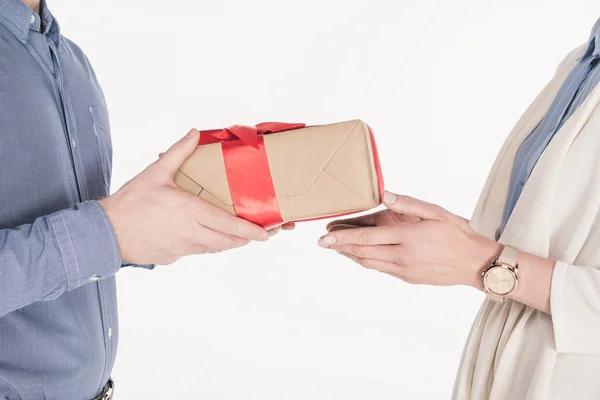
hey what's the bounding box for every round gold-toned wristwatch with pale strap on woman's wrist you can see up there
[481,246,519,303]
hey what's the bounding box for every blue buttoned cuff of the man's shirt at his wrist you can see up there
[47,201,121,290]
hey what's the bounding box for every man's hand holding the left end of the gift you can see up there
[100,129,269,265]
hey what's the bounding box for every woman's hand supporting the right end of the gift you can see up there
[319,192,502,289]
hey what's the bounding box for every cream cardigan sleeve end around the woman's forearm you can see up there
[550,261,600,354]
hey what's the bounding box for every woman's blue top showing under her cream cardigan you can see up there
[499,19,600,234]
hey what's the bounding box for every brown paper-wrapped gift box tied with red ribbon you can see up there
[174,120,383,229]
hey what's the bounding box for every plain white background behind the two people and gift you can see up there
[49,0,600,400]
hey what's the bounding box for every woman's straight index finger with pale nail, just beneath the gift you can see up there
[319,223,413,248]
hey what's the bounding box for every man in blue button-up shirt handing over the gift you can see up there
[0,0,269,400]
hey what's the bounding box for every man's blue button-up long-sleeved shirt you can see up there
[0,0,149,400]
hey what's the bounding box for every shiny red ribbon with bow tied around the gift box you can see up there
[198,122,306,229]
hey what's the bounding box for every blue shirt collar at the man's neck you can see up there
[0,0,60,44]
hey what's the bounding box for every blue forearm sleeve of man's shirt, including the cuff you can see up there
[0,201,121,317]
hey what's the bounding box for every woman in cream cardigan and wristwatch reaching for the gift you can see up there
[319,19,600,400]
